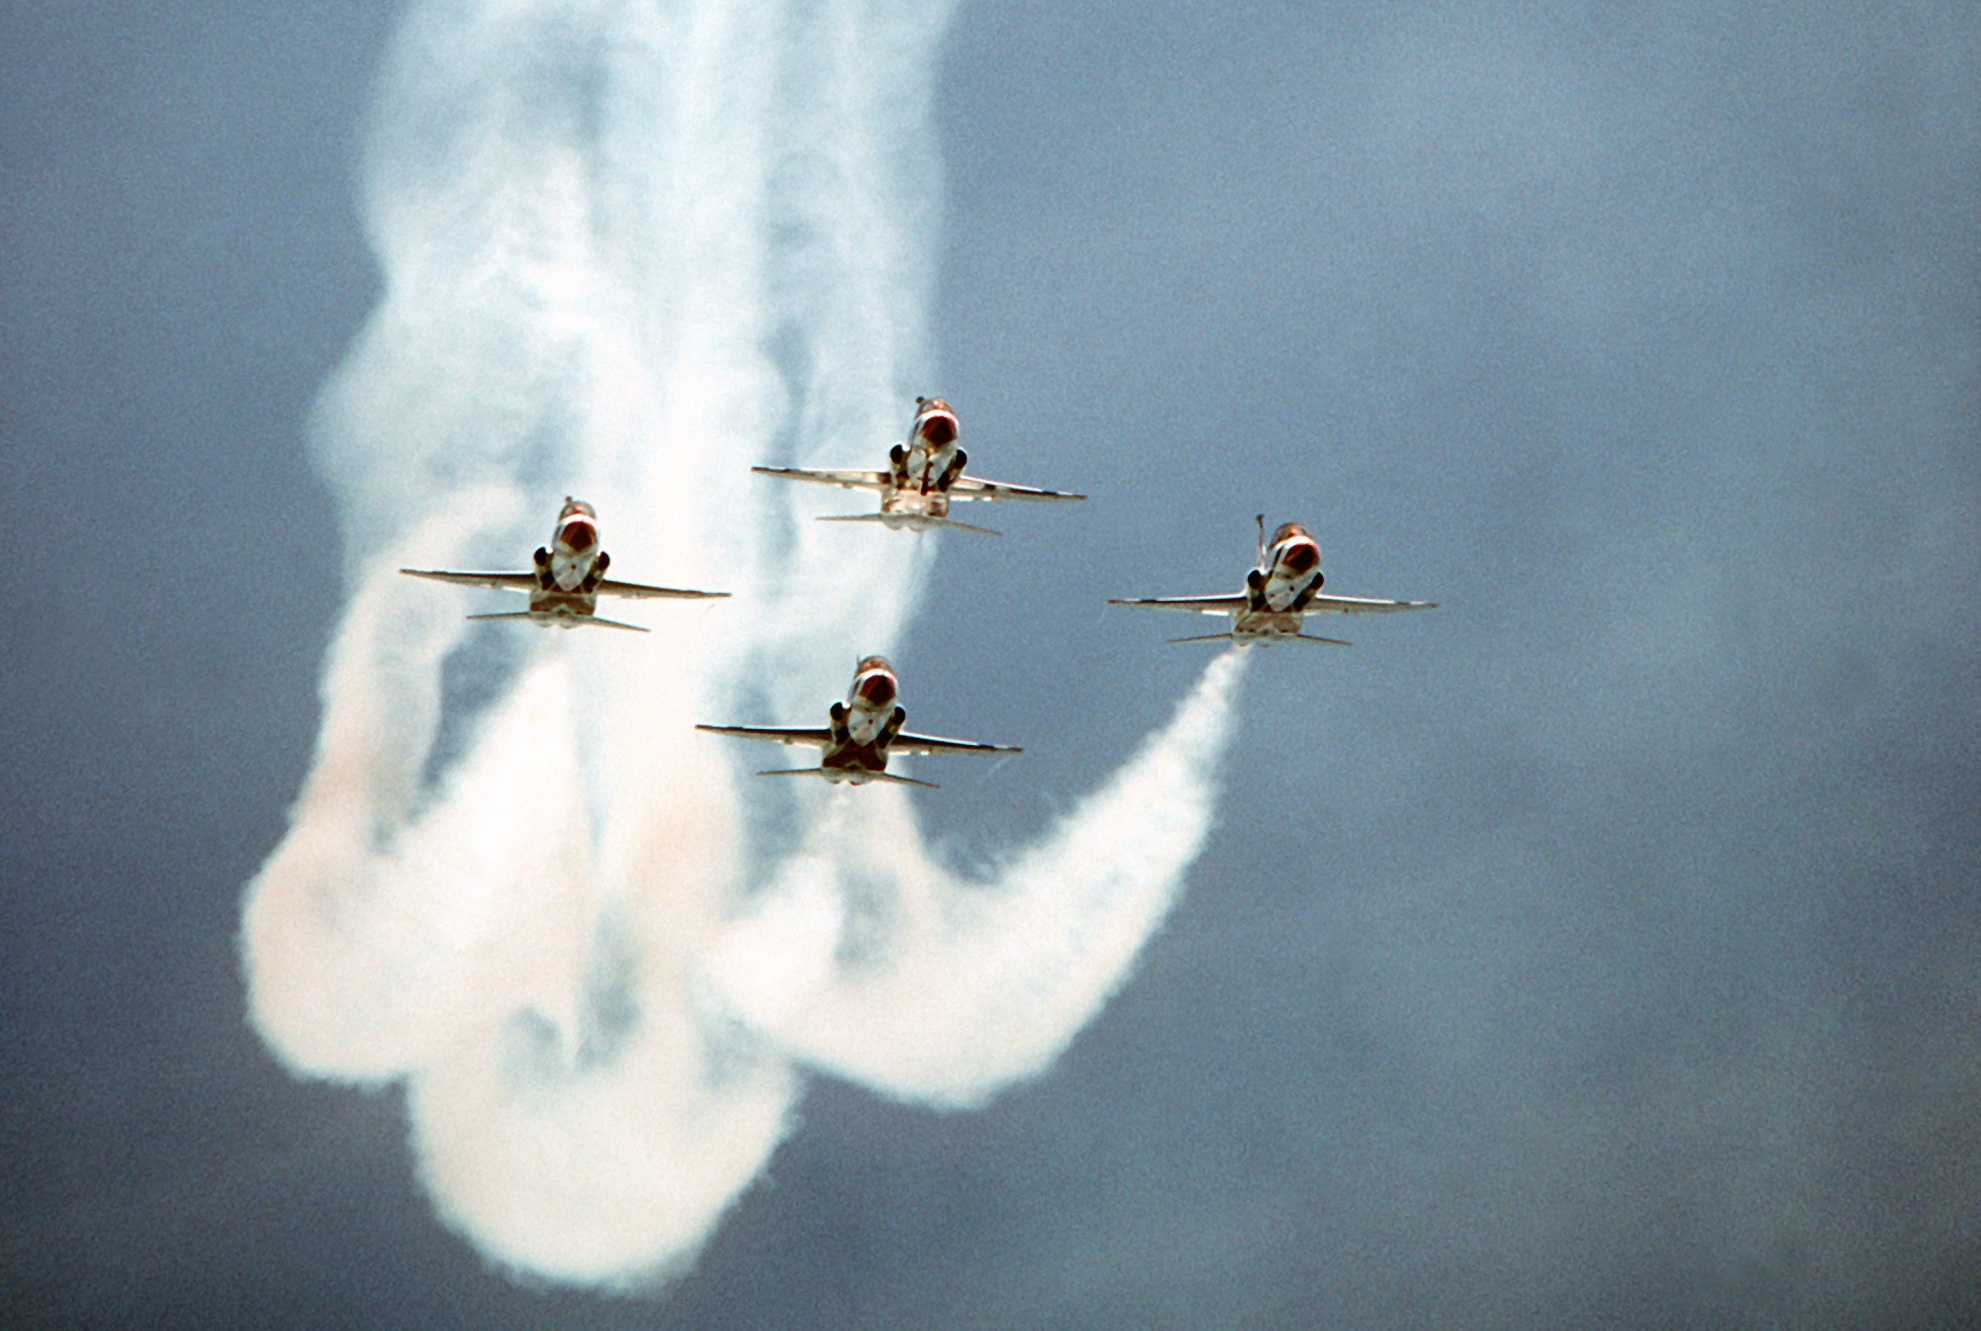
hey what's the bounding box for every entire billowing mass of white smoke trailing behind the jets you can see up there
[244,0,1240,1285]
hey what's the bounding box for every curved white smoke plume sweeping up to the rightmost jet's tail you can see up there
[709,650,1246,1105]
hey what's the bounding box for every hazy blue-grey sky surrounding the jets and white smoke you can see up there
[0,2,1981,1327]
